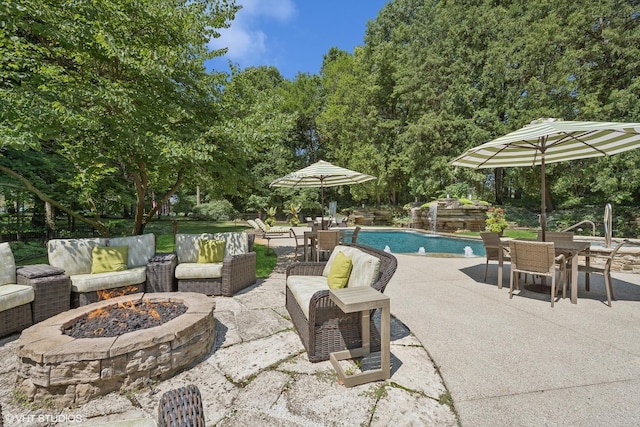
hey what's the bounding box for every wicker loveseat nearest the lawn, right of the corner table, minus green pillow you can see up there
[175,232,257,296]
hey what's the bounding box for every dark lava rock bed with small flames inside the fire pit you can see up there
[64,302,187,338]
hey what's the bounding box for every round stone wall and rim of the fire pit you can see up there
[16,292,215,407]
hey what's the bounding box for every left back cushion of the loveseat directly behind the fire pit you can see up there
[47,237,107,276]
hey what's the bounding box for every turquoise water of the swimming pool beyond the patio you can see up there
[345,230,485,256]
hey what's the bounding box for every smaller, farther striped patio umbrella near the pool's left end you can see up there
[269,160,376,227]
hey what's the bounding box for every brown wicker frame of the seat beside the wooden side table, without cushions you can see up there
[285,245,398,362]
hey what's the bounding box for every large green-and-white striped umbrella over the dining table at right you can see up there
[451,119,640,240]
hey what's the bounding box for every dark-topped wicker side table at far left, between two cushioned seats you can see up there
[16,264,71,323]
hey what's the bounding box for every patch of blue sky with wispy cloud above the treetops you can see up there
[207,0,390,80]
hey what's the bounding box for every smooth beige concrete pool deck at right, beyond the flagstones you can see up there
[274,231,640,427]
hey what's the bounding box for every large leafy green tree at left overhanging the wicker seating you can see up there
[0,0,237,234]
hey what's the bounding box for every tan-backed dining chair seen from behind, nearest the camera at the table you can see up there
[509,240,567,307]
